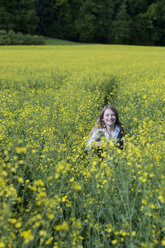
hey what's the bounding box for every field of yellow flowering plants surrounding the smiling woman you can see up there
[0,45,165,248]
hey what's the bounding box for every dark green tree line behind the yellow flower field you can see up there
[0,0,165,46]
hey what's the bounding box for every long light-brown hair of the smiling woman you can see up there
[91,105,125,134]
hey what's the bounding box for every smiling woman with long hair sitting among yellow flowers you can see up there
[87,105,125,151]
